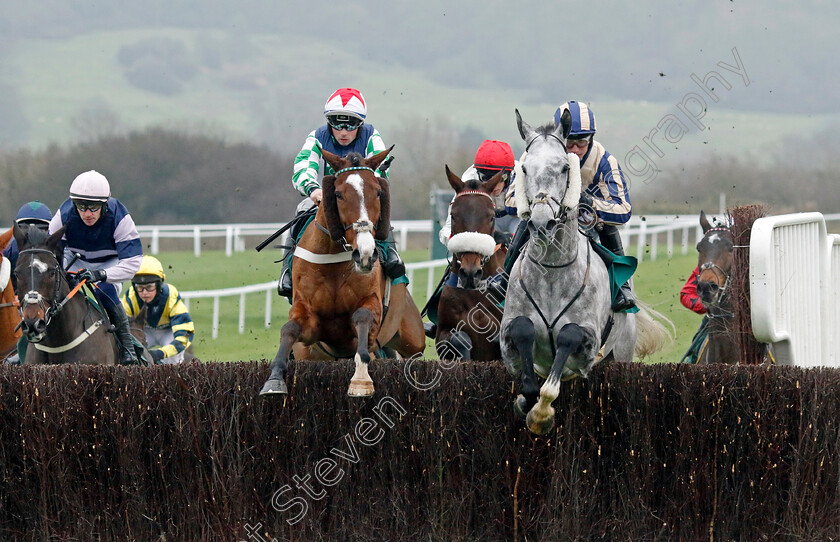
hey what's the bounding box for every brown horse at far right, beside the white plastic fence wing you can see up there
[697,211,739,363]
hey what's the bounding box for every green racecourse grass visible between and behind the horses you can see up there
[139,250,700,363]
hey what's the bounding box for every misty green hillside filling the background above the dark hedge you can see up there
[0,0,840,222]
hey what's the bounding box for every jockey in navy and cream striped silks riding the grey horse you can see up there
[505,101,636,311]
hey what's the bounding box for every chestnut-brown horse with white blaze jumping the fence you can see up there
[260,147,426,397]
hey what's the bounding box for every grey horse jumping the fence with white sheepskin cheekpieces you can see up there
[501,110,669,434]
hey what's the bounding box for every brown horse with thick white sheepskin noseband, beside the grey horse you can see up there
[435,166,507,361]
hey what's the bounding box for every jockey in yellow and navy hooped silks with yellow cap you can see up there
[122,256,195,364]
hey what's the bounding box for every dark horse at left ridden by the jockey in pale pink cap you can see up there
[14,225,118,365]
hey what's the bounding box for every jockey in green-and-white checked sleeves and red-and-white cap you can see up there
[277,88,405,300]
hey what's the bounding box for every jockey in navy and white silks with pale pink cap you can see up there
[49,170,143,365]
